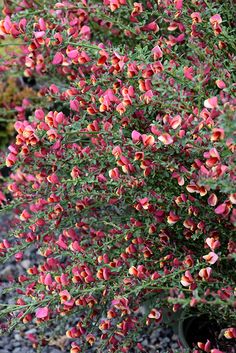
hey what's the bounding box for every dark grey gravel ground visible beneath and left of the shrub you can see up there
[0,216,183,353]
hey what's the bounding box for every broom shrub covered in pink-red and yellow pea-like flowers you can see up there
[0,0,236,353]
